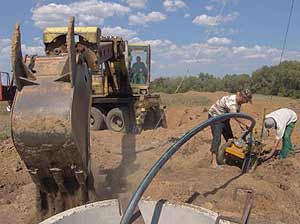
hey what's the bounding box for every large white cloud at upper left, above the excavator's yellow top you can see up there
[31,0,130,28]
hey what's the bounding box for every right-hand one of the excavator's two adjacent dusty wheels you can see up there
[106,107,129,133]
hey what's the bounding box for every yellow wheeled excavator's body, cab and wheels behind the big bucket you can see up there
[44,27,166,132]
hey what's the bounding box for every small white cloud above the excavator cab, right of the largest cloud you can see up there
[128,12,167,25]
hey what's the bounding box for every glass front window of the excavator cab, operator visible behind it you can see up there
[128,49,149,84]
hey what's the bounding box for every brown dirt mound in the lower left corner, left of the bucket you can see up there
[0,140,35,224]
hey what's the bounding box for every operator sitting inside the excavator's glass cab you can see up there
[131,56,147,84]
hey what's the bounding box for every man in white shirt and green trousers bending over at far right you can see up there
[264,108,298,159]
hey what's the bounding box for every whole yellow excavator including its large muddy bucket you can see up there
[11,17,166,219]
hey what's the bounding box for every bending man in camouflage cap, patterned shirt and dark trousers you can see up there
[208,89,252,168]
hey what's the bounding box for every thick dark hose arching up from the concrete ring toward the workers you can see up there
[120,113,255,224]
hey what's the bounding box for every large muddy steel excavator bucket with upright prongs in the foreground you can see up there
[11,17,91,218]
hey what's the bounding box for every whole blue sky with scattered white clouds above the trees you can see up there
[0,0,300,77]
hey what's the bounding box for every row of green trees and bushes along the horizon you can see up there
[151,61,300,98]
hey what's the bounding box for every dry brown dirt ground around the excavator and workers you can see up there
[0,92,300,224]
